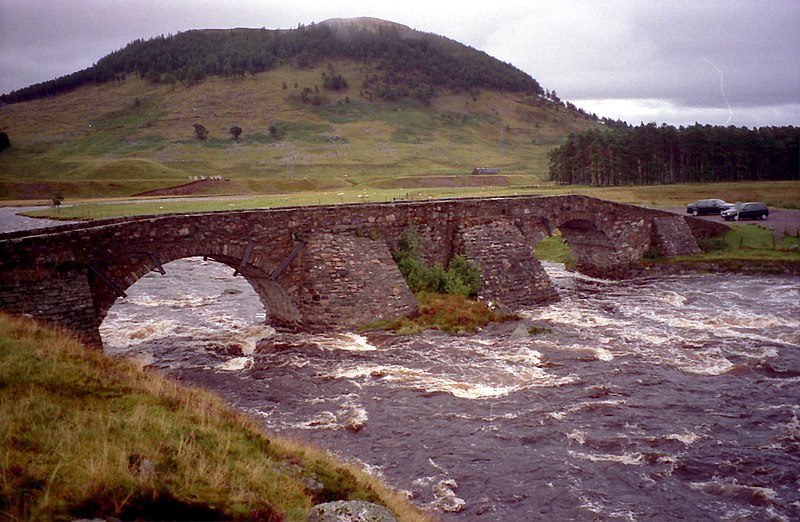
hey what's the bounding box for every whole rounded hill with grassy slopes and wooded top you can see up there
[0,19,597,199]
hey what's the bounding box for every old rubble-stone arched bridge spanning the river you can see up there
[0,195,727,347]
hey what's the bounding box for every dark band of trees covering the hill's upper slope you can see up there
[0,24,543,103]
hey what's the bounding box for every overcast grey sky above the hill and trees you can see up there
[0,0,800,127]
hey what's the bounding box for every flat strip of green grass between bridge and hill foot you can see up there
[17,180,800,220]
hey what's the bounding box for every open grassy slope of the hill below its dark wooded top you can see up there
[0,60,596,200]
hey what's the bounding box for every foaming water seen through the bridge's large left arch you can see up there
[100,257,274,360]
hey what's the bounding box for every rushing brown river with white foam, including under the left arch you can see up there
[102,258,800,521]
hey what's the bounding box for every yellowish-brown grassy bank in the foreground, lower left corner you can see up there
[0,315,426,521]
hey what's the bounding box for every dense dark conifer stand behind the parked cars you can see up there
[549,123,800,186]
